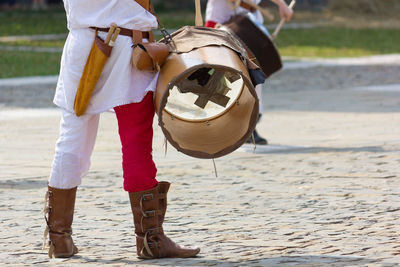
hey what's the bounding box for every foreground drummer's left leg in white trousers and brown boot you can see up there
[45,110,99,258]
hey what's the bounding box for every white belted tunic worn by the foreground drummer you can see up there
[54,0,158,114]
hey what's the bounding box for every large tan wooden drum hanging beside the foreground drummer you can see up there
[155,26,258,158]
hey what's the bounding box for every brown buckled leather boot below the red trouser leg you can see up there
[129,182,200,259]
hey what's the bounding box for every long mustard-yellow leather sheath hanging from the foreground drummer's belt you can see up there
[74,31,112,116]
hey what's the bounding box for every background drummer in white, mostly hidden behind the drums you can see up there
[205,0,293,145]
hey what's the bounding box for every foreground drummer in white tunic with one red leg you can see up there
[45,0,199,258]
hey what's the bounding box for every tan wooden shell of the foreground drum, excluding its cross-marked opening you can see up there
[155,46,259,158]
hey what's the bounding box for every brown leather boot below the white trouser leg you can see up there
[44,186,78,258]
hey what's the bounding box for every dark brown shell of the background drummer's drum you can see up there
[224,14,282,77]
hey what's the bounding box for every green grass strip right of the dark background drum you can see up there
[276,27,400,58]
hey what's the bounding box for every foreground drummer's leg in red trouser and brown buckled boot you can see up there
[114,93,200,259]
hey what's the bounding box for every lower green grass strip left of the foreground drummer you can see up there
[0,51,61,78]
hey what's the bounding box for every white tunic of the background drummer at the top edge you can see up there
[206,0,264,24]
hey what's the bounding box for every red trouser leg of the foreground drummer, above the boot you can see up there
[114,92,158,192]
